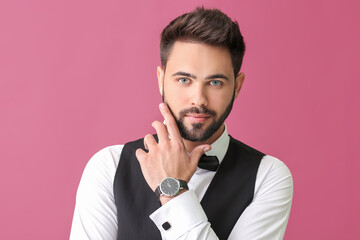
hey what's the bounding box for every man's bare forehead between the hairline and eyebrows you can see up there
[166,41,234,79]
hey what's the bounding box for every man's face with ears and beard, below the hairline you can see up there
[158,41,244,142]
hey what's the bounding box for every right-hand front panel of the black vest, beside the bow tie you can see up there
[201,137,264,239]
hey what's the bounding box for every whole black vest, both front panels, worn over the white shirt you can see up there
[114,137,264,240]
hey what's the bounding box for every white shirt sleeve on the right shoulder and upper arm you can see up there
[229,155,293,240]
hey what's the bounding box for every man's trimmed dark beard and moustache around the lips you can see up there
[163,91,235,142]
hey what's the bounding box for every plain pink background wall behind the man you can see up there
[0,0,360,240]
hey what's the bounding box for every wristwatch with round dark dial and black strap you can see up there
[155,177,189,199]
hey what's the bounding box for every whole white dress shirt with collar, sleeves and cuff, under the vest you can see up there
[70,128,293,240]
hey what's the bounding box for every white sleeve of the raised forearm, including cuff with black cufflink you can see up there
[150,190,218,240]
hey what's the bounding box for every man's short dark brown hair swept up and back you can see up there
[160,6,245,77]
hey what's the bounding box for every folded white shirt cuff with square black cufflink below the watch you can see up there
[150,190,207,239]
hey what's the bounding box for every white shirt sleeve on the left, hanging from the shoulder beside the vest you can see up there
[70,145,122,240]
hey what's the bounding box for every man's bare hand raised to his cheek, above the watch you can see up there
[136,103,211,195]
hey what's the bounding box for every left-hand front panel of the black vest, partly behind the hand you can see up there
[114,139,161,240]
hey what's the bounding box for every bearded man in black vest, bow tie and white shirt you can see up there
[70,8,293,240]
